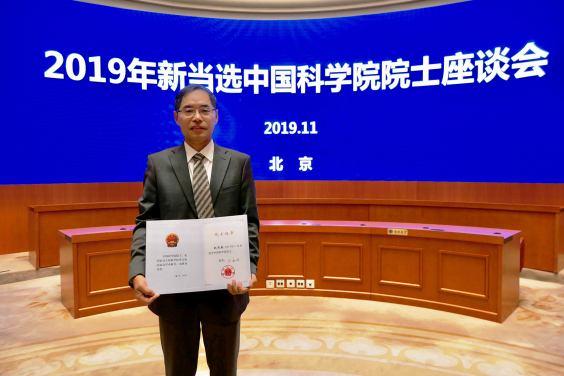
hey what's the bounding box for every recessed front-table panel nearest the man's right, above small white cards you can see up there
[266,242,306,278]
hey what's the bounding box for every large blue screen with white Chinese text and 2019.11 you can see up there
[0,0,564,185]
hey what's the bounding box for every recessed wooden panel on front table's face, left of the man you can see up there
[86,248,131,296]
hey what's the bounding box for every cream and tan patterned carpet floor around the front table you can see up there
[0,254,564,376]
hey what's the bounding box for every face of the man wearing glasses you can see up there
[174,90,217,151]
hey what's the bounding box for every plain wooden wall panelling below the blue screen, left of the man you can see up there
[0,183,143,254]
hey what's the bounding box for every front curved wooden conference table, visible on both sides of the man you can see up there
[59,220,521,322]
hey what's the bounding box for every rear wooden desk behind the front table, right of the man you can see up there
[257,198,564,273]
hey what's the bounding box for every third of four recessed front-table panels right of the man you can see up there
[378,246,423,288]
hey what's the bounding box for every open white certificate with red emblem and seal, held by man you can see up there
[145,215,251,294]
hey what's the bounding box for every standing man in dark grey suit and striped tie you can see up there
[129,85,259,376]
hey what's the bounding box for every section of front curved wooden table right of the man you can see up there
[251,220,521,322]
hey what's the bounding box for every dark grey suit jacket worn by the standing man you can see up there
[129,143,259,321]
